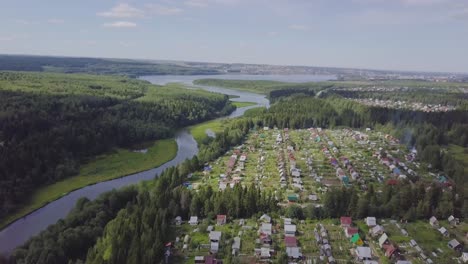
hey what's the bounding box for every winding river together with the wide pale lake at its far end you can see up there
[0,75,334,255]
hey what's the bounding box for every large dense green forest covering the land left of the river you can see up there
[0,72,234,221]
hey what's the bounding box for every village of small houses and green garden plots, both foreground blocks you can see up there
[167,127,468,264]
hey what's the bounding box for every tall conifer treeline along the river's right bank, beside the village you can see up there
[9,119,256,264]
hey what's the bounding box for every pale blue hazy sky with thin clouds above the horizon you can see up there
[0,0,468,73]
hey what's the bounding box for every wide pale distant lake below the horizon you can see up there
[141,74,336,85]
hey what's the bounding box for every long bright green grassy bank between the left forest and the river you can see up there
[0,139,177,229]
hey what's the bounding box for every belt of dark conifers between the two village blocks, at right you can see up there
[322,182,468,221]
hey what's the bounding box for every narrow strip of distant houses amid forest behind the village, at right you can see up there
[352,98,456,112]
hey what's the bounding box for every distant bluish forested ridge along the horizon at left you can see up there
[0,55,219,76]
